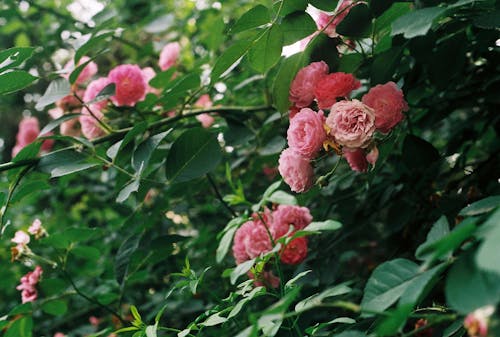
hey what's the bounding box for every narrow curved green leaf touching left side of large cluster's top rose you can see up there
[273,53,306,113]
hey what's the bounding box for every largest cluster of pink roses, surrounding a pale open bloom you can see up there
[279,61,408,192]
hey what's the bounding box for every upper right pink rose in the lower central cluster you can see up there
[270,205,312,240]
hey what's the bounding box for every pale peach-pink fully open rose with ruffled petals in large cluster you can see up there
[326,99,375,148]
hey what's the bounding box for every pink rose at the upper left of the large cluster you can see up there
[289,61,328,108]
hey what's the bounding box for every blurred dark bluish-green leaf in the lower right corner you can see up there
[445,252,500,314]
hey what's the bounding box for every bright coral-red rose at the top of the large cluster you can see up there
[314,72,361,109]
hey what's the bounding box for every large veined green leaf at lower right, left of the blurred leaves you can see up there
[361,259,418,314]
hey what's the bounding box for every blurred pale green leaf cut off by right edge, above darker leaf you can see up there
[471,207,500,275]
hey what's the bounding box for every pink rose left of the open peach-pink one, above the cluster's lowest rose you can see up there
[287,108,326,158]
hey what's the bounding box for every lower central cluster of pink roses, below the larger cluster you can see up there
[233,205,312,288]
